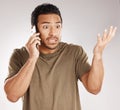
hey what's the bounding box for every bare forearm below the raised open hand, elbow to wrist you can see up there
[87,55,104,93]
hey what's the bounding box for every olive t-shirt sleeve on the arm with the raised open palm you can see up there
[75,46,91,79]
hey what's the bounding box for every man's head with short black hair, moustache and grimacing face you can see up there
[31,4,62,51]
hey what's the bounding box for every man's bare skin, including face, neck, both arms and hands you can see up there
[4,14,116,102]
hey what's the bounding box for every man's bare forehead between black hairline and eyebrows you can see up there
[38,14,61,24]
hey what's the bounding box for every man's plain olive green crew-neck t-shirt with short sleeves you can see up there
[8,42,90,110]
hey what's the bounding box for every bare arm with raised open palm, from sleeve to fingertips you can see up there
[80,26,117,94]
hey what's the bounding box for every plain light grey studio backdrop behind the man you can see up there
[0,0,120,110]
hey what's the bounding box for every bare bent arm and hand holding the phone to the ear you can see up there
[4,33,40,102]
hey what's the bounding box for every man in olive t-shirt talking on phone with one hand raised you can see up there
[4,4,116,110]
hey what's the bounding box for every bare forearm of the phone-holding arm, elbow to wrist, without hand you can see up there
[4,58,36,101]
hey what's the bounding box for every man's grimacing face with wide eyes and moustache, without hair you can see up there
[37,14,62,50]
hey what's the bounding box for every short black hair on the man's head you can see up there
[31,3,62,28]
